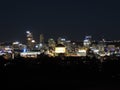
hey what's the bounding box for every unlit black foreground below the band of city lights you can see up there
[0,57,120,90]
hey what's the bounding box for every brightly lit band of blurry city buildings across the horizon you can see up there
[0,31,120,59]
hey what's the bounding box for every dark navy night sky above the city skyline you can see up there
[0,0,120,41]
